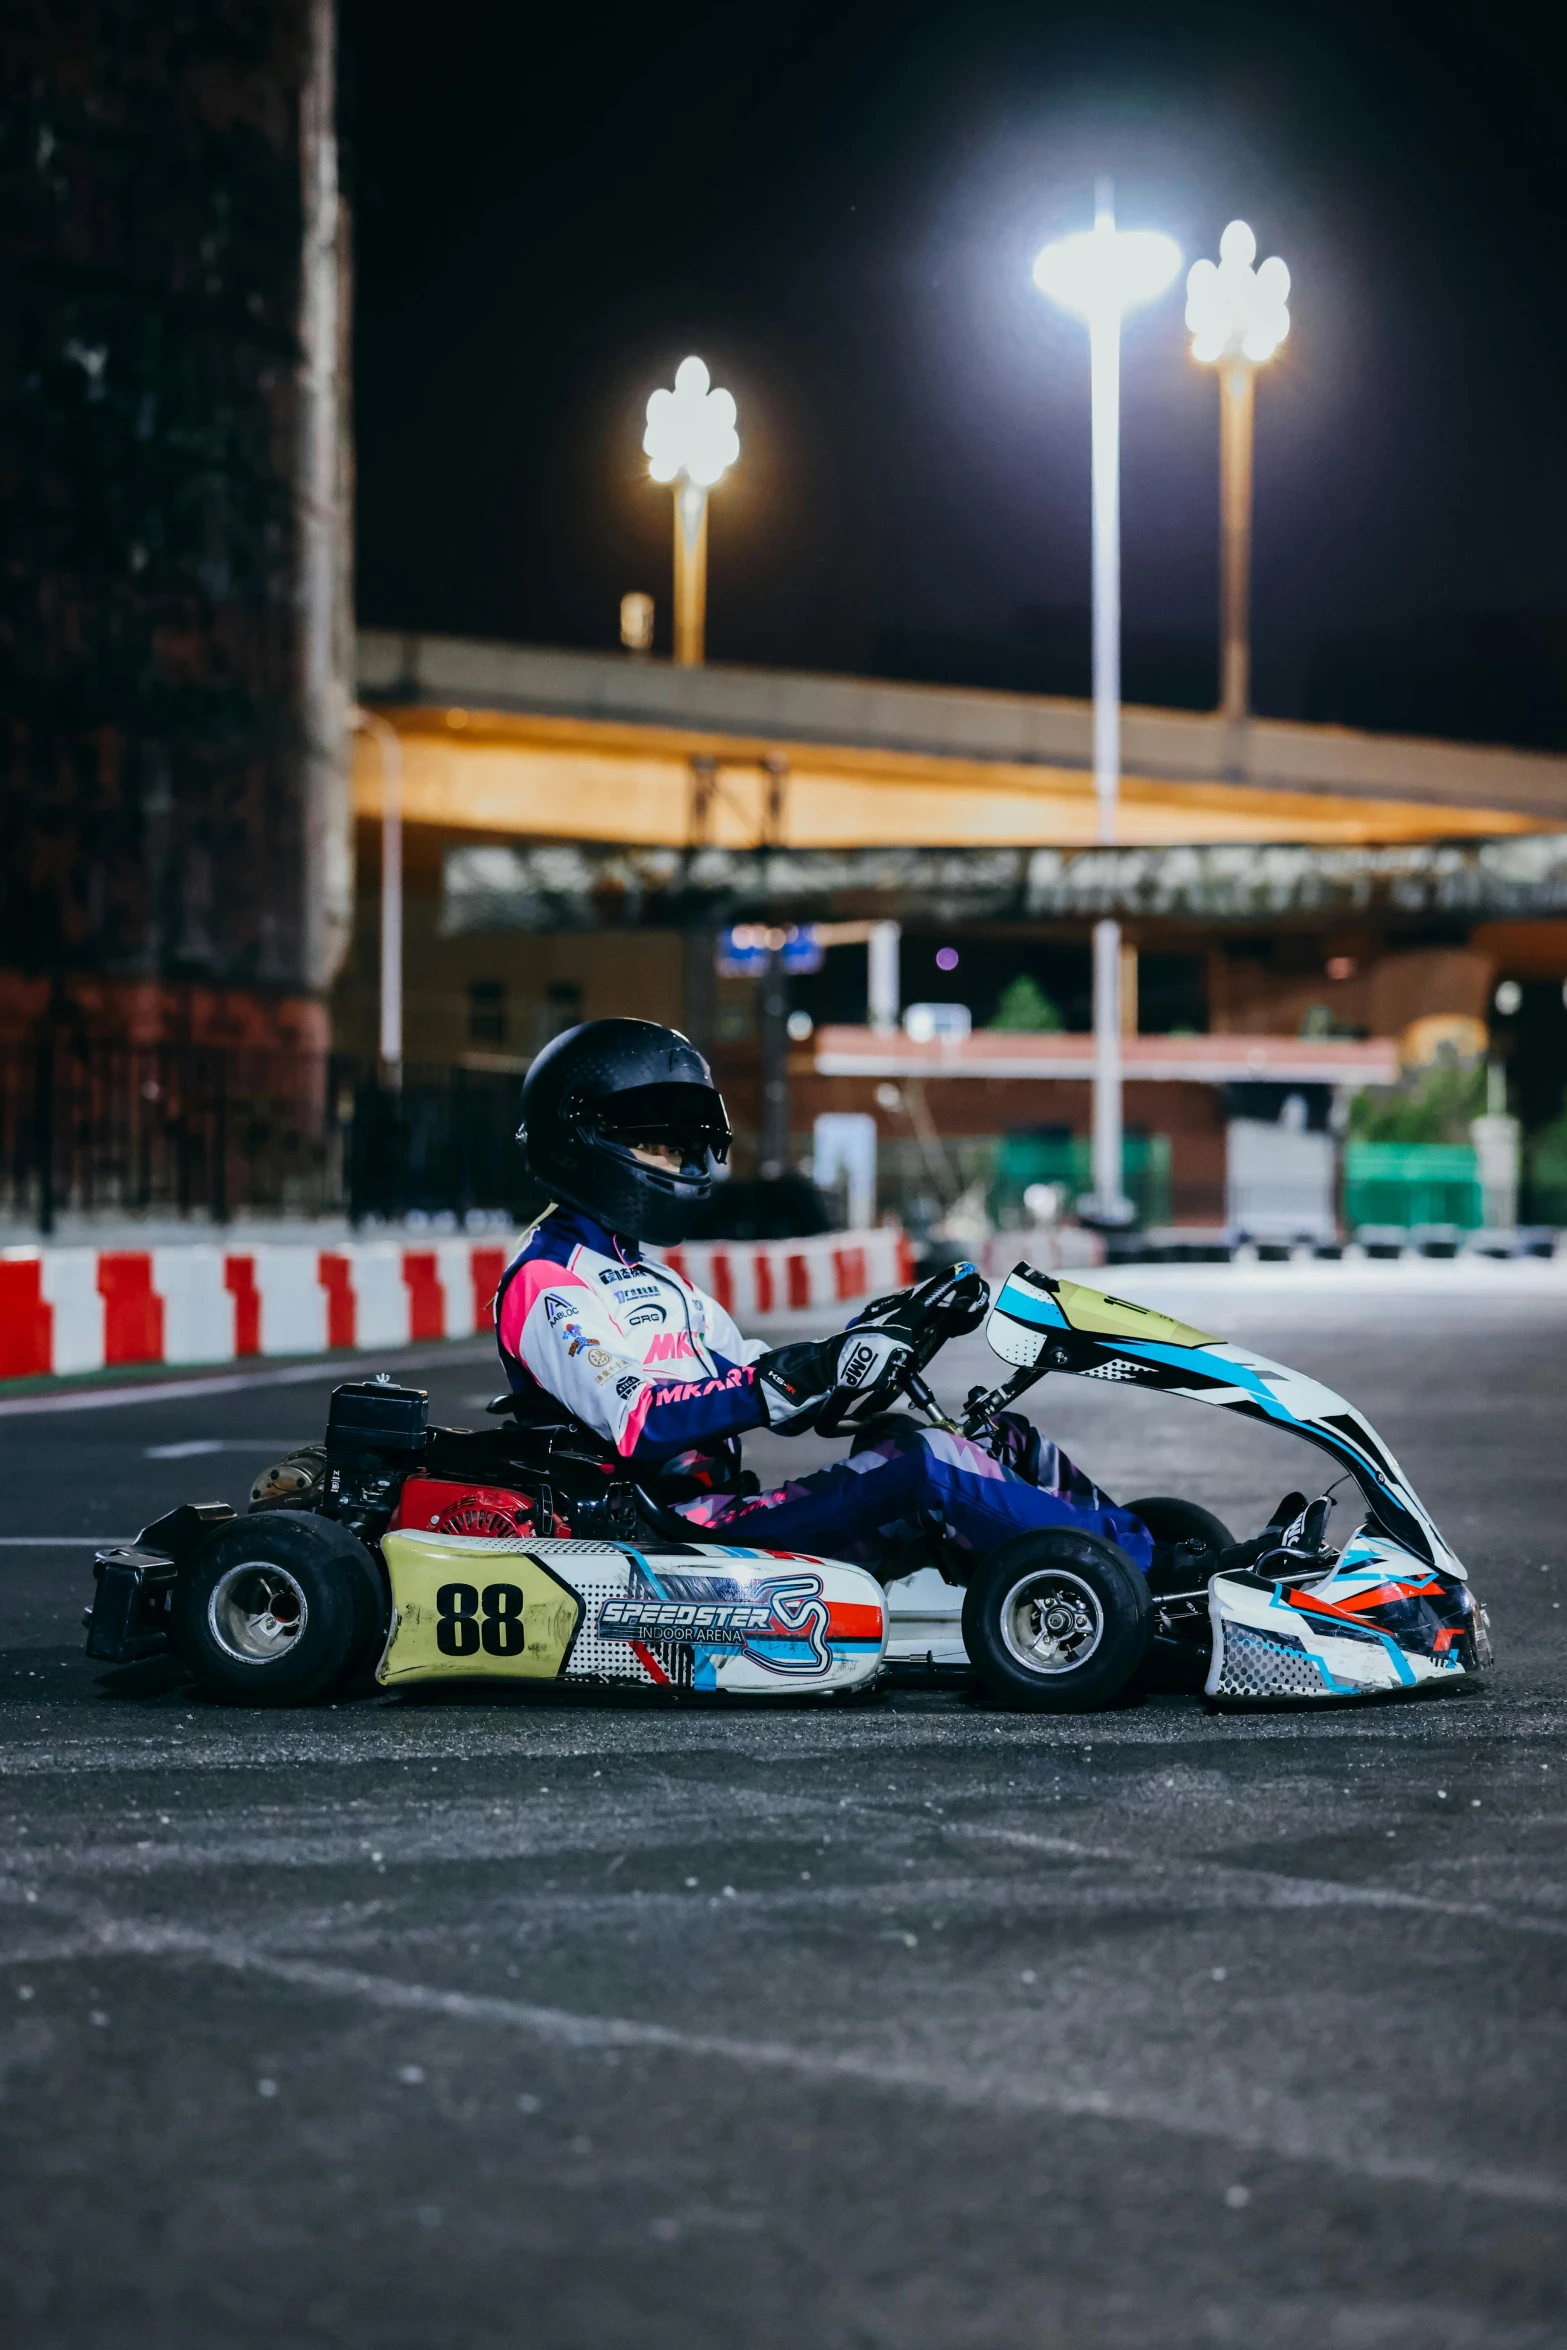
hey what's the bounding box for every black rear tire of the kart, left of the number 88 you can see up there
[174,1509,385,1706]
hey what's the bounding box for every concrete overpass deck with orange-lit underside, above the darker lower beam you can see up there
[355,630,1567,853]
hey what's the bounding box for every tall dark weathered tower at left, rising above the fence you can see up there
[0,0,352,1053]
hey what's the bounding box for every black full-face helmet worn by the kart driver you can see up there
[517,1020,731,1248]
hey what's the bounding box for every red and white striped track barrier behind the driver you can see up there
[0,1231,914,1379]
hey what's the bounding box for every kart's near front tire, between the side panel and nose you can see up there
[963,1525,1154,1713]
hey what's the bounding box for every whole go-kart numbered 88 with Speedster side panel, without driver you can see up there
[87,1264,1489,1711]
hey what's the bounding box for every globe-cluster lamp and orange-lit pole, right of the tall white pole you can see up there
[1186,221,1290,733]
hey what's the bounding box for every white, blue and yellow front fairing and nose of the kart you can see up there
[987,1267,1492,1701]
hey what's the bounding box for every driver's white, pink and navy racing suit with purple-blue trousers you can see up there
[496,1208,1154,1572]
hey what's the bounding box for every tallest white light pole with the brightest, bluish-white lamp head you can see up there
[1034,179,1182,1224]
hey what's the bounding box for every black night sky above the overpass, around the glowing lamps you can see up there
[343,0,1567,745]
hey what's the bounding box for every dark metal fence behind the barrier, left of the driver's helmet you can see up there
[0,1036,536,1231]
